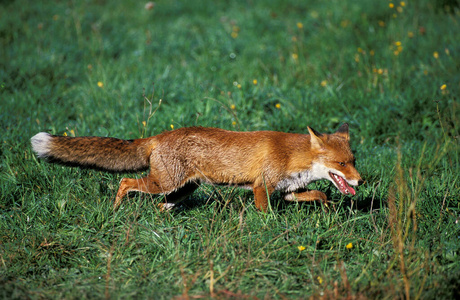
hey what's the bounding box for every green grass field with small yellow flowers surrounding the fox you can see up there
[0,0,460,299]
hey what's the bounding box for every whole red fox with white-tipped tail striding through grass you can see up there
[31,123,363,211]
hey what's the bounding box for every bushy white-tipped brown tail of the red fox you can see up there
[30,132,150,172]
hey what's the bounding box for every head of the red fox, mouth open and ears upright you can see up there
[308,123,363,195]
